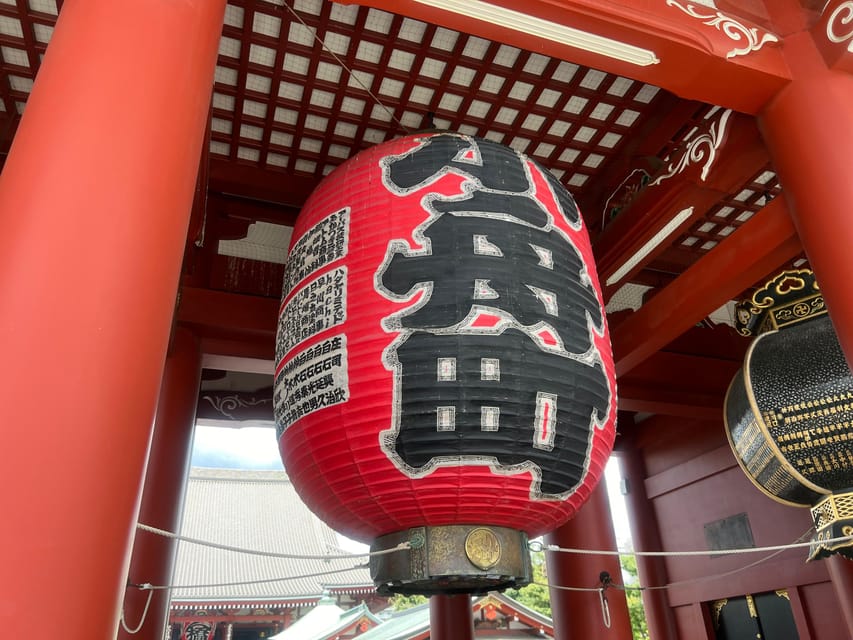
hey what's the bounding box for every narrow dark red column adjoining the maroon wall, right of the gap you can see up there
[619,440,678,640]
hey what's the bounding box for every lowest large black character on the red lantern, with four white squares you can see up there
[393,329,610,495]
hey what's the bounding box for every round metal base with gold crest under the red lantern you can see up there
[370,525,532,596]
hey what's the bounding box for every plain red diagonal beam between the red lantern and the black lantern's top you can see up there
[612,198,802,376]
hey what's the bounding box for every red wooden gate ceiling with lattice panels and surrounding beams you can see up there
[0,0,816,419]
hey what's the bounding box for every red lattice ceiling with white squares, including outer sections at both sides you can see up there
[0,0,800,304]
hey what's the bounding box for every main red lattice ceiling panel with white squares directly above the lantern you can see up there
[211,0,662,196]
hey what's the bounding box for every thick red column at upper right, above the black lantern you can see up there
[759,32,853,363]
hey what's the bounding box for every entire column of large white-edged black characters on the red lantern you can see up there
[376,134,613,498]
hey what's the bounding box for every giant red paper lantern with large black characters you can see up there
[275,133,616,591]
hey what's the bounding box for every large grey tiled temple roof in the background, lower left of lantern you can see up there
[172,469,373,602]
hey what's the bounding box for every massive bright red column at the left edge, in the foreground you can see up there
[0,0,225,639]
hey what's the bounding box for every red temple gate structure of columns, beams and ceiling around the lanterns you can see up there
[0,0,853,640]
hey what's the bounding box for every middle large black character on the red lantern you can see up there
[381,213,603,353]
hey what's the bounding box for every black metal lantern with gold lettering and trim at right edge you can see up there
[725,270,853,560]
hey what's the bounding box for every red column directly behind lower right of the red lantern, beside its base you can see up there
[545,481,633,640]
